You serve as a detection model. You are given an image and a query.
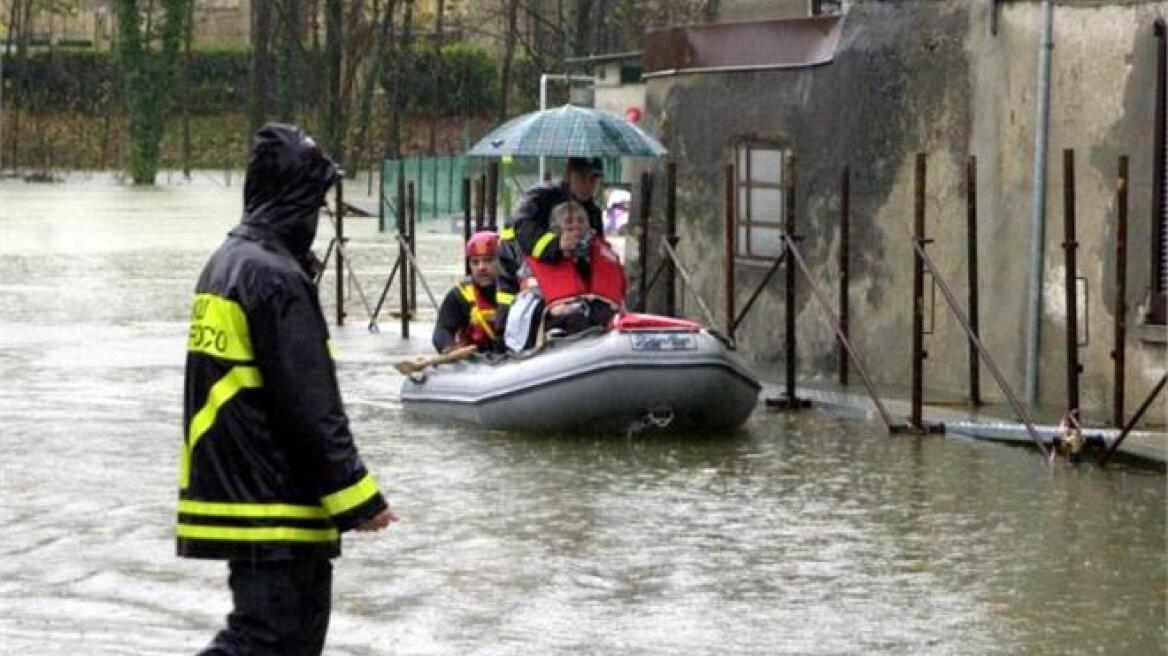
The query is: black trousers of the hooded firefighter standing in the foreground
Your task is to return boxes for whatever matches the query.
[200,559,333,656]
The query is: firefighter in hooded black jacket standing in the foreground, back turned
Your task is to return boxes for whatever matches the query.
[178,124,396,656]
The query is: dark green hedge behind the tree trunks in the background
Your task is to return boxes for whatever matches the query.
[4,43,499,116]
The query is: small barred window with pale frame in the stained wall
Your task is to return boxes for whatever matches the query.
[735,141,790,263]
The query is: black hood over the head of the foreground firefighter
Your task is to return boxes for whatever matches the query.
[243,123,340,258]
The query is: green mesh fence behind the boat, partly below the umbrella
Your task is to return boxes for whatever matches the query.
[381,155,621,232]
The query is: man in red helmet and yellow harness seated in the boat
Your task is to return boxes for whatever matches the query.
[433,231,499,353]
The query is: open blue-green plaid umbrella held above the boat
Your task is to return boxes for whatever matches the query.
[466,105,667,158]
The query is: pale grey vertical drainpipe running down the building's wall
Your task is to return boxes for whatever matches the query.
[1026,0,1055,407]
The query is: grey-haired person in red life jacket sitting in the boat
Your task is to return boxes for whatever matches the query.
[527,201,625,335]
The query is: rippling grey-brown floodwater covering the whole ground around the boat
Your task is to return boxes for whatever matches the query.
[0,176,1168,656]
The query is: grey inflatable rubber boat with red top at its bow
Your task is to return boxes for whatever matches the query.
[402,314,762,432]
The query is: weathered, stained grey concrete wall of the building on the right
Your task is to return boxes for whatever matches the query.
[627,0,1168,423]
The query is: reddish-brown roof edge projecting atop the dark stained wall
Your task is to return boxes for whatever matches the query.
[645,16,842,77]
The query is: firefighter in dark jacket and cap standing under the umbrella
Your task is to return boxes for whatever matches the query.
[495,158,604,333]
